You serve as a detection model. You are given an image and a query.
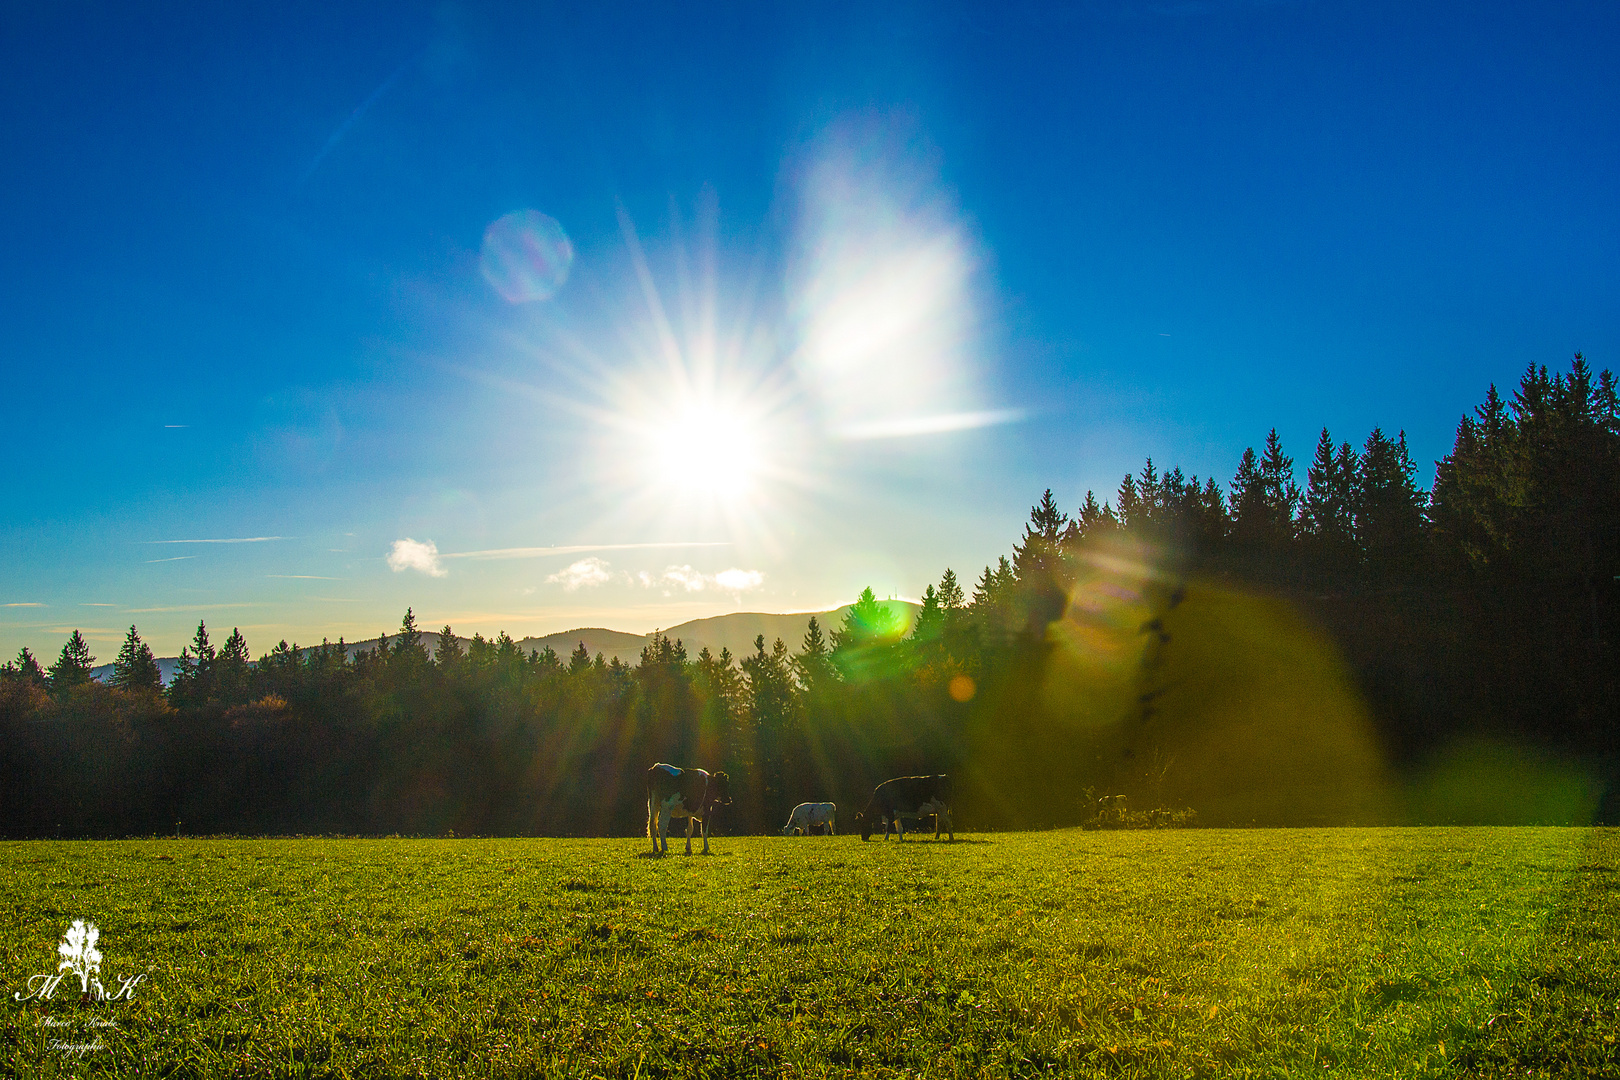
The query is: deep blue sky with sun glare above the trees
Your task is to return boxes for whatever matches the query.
[0,2,1620,659]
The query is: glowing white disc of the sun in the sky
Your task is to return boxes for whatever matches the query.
[646,403,765,502]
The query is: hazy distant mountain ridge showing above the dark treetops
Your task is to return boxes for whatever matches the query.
[91,601,917,685]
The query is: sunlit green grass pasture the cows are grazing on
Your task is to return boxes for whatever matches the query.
[0,829,1620,1077]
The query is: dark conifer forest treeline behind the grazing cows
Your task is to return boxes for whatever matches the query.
[0,355,1620,836]
